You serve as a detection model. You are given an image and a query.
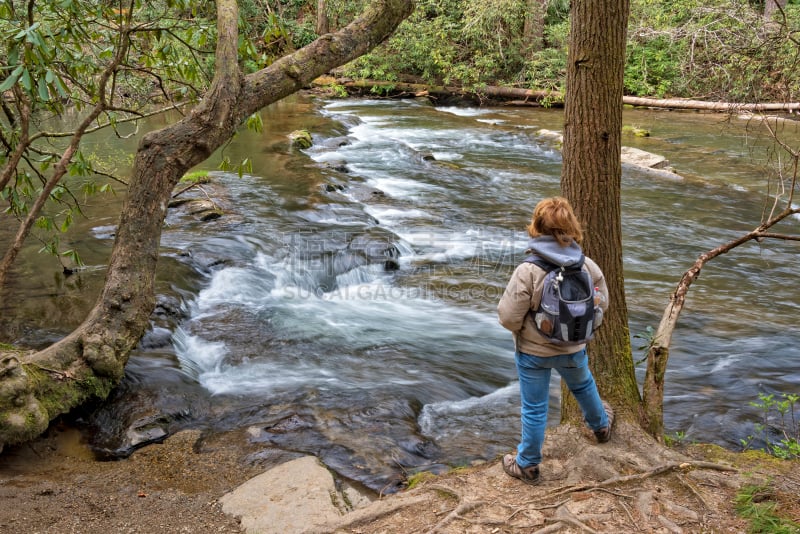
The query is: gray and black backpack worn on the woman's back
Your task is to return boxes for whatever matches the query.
[525,255,603,345]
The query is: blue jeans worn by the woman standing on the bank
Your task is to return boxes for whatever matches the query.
[515,349,608,468]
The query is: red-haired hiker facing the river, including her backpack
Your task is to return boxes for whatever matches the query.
[497,197,614,484]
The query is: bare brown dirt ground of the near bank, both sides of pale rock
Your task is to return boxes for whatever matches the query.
[0,425,800,534]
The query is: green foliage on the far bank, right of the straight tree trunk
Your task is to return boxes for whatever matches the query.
[625,0,800,102]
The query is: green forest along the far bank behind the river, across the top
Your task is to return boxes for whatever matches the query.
[252,0,800,102]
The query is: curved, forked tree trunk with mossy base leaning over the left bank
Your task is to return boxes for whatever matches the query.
[0,0,413,449]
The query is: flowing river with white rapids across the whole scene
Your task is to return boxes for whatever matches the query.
[3,96,800,489]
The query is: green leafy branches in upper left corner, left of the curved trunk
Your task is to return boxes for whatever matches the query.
[0,0,216,269]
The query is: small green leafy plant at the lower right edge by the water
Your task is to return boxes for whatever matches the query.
[741,393,800,460]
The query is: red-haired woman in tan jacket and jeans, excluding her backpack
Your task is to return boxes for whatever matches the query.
[497,197,614,484]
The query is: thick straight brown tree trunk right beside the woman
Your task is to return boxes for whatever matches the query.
[561,0,641,428]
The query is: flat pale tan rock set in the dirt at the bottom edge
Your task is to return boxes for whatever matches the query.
[220,456,371,534]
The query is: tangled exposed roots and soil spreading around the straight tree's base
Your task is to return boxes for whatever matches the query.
[326,428,746,534]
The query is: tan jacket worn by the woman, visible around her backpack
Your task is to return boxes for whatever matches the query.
[497,258,608,356]
